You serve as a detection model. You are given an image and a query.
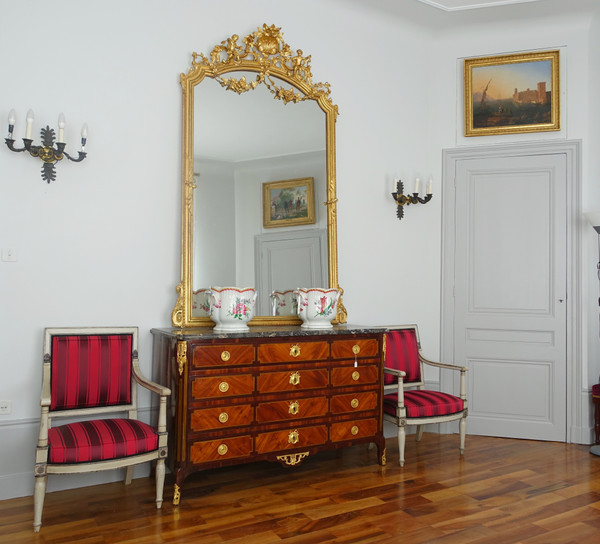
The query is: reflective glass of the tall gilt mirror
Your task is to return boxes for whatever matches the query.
[192,72,327,317]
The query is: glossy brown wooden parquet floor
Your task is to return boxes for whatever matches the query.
[0,433,600,544]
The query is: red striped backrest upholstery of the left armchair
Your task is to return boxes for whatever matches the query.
[50,334,132,410]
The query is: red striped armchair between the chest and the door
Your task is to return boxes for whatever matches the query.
[383,325,467,466]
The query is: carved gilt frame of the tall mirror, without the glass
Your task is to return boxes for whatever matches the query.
[171,24,347,328]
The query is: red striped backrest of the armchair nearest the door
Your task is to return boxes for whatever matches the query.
[384,325,421,384]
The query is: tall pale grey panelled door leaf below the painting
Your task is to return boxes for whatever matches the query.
[453,153,567,441]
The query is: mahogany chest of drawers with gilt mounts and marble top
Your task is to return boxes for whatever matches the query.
[152,326,385,504]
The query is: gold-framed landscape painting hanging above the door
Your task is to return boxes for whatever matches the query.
[465,50,560,136]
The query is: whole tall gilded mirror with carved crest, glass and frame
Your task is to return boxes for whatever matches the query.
[171,24,347,327]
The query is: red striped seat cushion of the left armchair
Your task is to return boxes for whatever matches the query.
[48,418,158,464]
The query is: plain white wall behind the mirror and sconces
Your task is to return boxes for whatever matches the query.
[0,0,599,498]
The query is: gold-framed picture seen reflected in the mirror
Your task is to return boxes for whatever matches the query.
[262,178,315,229]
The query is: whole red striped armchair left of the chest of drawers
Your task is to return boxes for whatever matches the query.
[33,327,171,532]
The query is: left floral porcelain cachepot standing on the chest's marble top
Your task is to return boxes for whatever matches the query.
[208,287,256,332]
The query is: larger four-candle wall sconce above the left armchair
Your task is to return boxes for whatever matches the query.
[4,110,87,183]
